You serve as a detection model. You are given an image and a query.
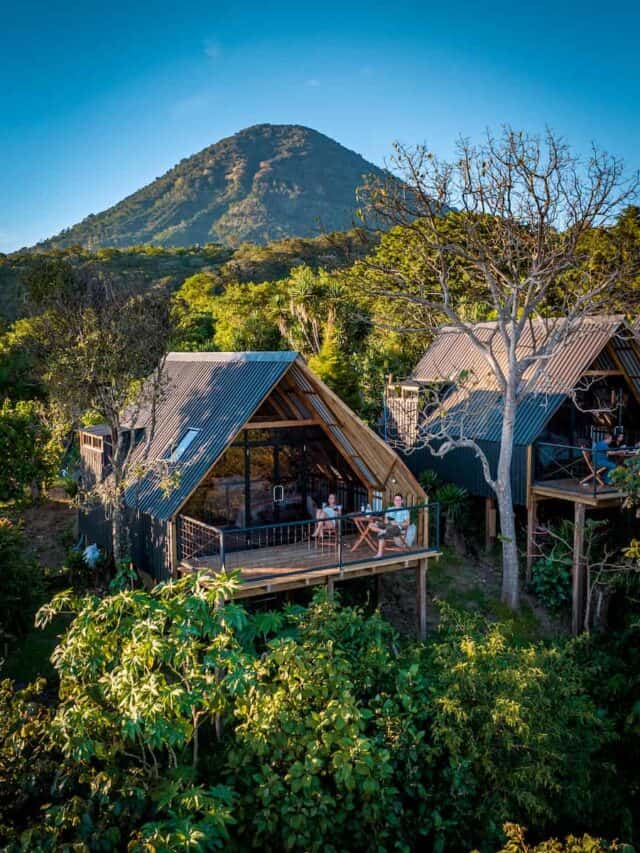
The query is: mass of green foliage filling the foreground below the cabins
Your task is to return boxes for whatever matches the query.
[0,578,610,853]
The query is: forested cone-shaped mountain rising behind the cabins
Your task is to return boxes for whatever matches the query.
[38,124,382,249]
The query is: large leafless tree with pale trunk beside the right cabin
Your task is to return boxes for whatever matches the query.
[362,128,638,608]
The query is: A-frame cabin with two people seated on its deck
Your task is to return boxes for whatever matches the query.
[80,352,437,628]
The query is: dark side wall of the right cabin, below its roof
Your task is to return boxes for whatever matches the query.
[403,441,527,506]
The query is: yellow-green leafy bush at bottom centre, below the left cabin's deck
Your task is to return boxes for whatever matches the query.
[229,605,401,850]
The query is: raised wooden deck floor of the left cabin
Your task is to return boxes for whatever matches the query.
[179,537,439,598]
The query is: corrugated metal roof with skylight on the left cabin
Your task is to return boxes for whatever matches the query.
[127,352,297,520]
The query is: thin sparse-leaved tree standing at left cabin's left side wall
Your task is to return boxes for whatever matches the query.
[27,260,171,563]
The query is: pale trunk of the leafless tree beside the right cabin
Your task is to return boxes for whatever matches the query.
[496,381,520,610]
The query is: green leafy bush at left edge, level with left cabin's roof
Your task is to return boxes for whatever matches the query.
[0,400,58,501]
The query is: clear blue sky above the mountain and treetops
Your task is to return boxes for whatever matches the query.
[0,0,640,252]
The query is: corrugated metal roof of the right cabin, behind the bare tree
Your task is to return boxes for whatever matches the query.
[411,315,628,444]
